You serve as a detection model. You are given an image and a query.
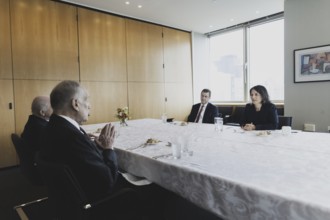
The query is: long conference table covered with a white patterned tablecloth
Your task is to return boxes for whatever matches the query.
[83,119,330,220]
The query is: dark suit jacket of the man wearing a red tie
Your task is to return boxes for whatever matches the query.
[188,103,219,124]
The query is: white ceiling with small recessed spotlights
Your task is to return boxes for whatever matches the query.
[62,0,284,34]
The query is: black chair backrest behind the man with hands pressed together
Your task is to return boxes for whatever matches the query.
[37,154,89,220]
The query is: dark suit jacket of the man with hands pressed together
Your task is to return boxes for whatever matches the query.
[40,114,118,199]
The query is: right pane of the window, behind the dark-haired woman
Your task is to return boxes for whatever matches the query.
[248,19,284,101]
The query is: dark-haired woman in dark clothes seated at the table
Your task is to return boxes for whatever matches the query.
[241,85,278,131]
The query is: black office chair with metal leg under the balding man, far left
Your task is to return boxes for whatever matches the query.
[11,133,47,219]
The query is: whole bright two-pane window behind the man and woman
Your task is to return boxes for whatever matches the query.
[209,16,284,103]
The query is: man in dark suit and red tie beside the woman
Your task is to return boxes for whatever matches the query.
[188,89,219,124]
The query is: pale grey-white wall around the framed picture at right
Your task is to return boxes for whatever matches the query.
[284,0,330,132]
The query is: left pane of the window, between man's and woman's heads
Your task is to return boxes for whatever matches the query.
[210,29,244,102]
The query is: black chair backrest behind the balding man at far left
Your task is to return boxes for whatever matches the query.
[11,133,43,185]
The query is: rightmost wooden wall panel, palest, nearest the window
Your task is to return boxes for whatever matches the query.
[163,28,193,121]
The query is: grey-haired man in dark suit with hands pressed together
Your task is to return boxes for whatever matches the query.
[40,80,141,219]
